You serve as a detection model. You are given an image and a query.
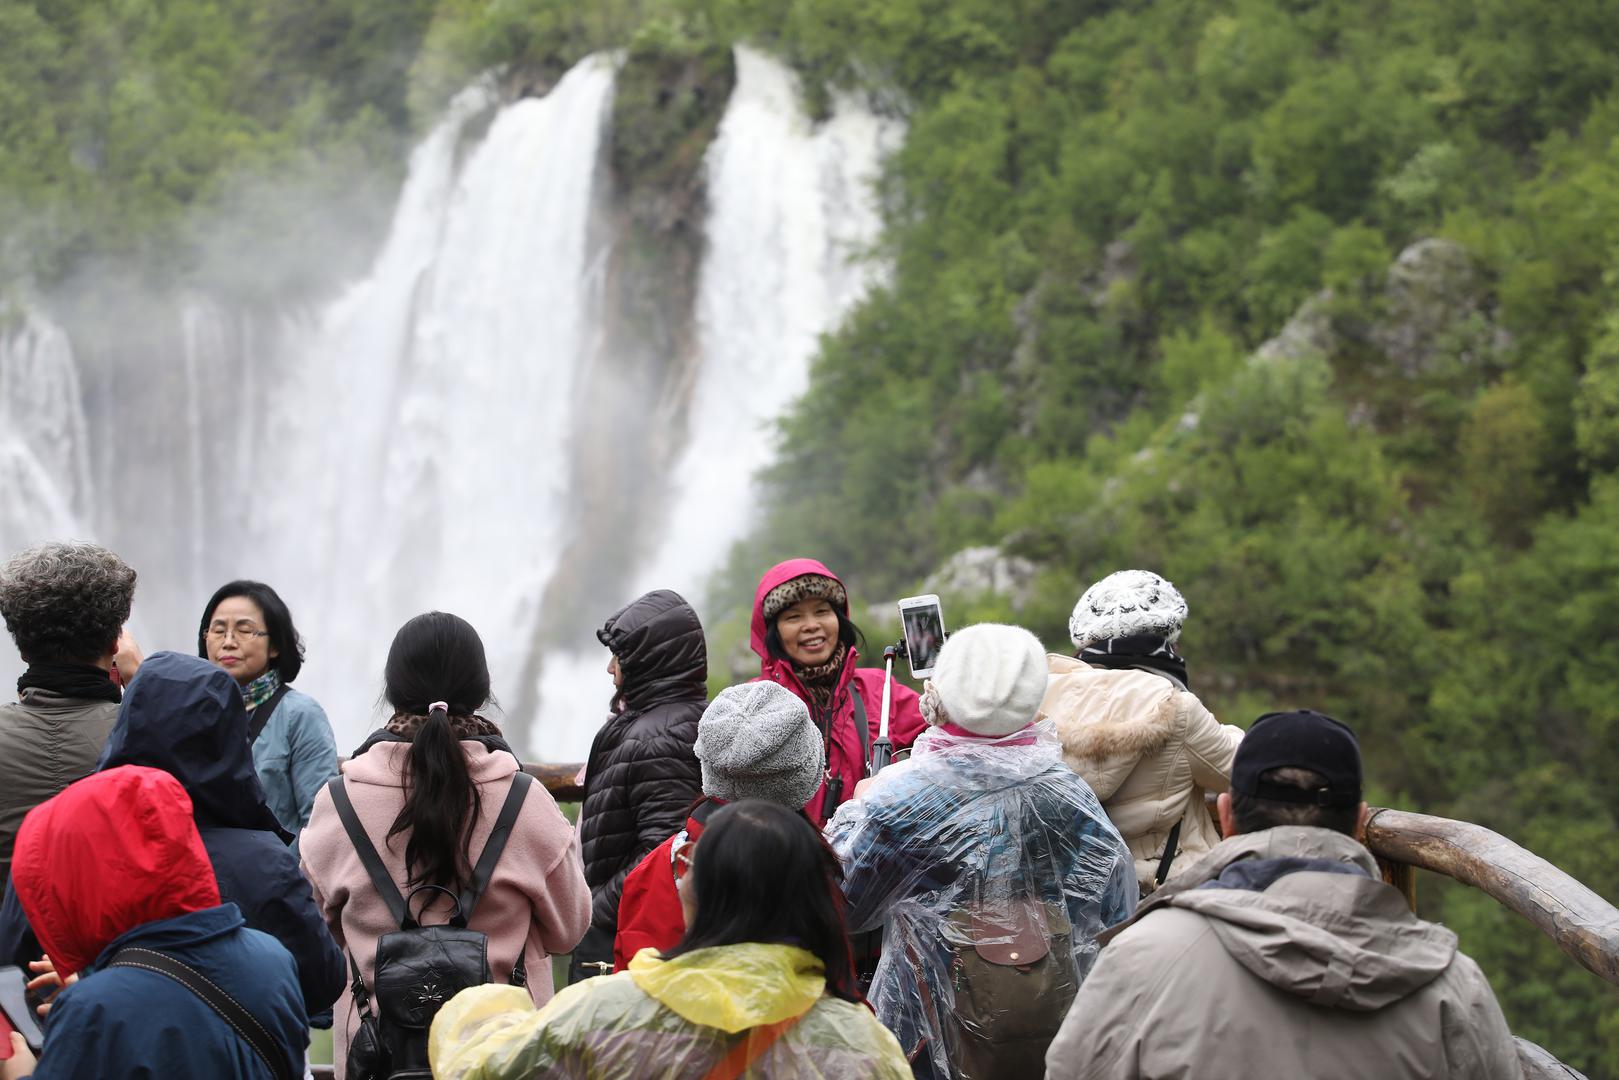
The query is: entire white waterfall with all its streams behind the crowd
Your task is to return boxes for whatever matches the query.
[0,50,897,761]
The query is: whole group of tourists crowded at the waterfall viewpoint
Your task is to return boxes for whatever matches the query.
[0,542,1522,1080]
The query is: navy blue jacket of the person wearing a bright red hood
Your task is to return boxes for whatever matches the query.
[34,904,309,1080]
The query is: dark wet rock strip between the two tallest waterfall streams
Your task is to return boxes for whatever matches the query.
[531,40,737,650]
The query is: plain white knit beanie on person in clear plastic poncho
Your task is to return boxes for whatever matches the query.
[928,622,1046,738]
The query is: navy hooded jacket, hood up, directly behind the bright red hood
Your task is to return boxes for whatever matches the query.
[0,653,346,1015]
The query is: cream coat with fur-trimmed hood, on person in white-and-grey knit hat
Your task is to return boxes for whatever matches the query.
[1039,654,1242,889]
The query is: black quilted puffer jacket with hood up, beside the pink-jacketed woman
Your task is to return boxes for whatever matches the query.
[580,589,708,939]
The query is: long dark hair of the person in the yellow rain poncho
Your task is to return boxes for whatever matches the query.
[664,798,861,1001]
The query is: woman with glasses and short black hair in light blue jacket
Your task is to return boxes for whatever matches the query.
[198,581,337,836]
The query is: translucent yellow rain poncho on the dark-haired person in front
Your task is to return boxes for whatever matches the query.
[427,944,911,1080]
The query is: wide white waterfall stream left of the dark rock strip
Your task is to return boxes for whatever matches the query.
[255,58,614,738]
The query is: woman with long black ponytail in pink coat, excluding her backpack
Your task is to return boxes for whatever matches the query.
[300,612,591,1080]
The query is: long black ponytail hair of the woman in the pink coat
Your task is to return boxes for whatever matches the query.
[382,612,489,886]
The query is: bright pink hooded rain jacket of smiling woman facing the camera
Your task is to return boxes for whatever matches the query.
[753,559,928,827]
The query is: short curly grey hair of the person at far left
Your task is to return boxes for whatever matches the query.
[0,541,134,664]
